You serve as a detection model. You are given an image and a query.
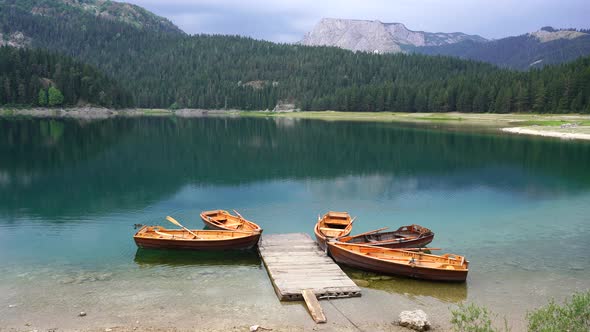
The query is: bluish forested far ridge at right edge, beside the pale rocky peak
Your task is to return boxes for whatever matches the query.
[413,27,590,70]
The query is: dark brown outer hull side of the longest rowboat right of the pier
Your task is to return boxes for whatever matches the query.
[327,243,468,282]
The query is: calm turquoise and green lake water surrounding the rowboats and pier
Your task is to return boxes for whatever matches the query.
[0,118,590,326]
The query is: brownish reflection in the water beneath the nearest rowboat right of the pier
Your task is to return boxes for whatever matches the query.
[342,266,468,303]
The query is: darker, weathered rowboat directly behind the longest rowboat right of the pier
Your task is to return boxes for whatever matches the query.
[338,224,434,248]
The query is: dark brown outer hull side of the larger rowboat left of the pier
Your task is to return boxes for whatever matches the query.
[134,233,261,250]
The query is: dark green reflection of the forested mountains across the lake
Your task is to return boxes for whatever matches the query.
[0,117,590,216]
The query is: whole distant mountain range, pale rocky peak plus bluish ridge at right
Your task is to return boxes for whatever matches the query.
[299,18,590,70]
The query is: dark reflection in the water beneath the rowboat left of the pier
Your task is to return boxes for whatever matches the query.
[134,248,261,267]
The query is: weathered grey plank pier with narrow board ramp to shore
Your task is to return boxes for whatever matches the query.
[258,233,361,322]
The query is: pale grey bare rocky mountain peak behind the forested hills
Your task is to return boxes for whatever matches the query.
[300,18,487,53]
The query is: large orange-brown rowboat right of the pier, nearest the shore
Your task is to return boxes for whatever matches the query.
[328,241,469,282]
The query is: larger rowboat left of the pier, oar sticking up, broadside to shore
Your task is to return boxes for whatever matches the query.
[133,226,261,250]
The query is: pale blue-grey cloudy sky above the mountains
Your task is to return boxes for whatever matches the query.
[130,0,590,42]
